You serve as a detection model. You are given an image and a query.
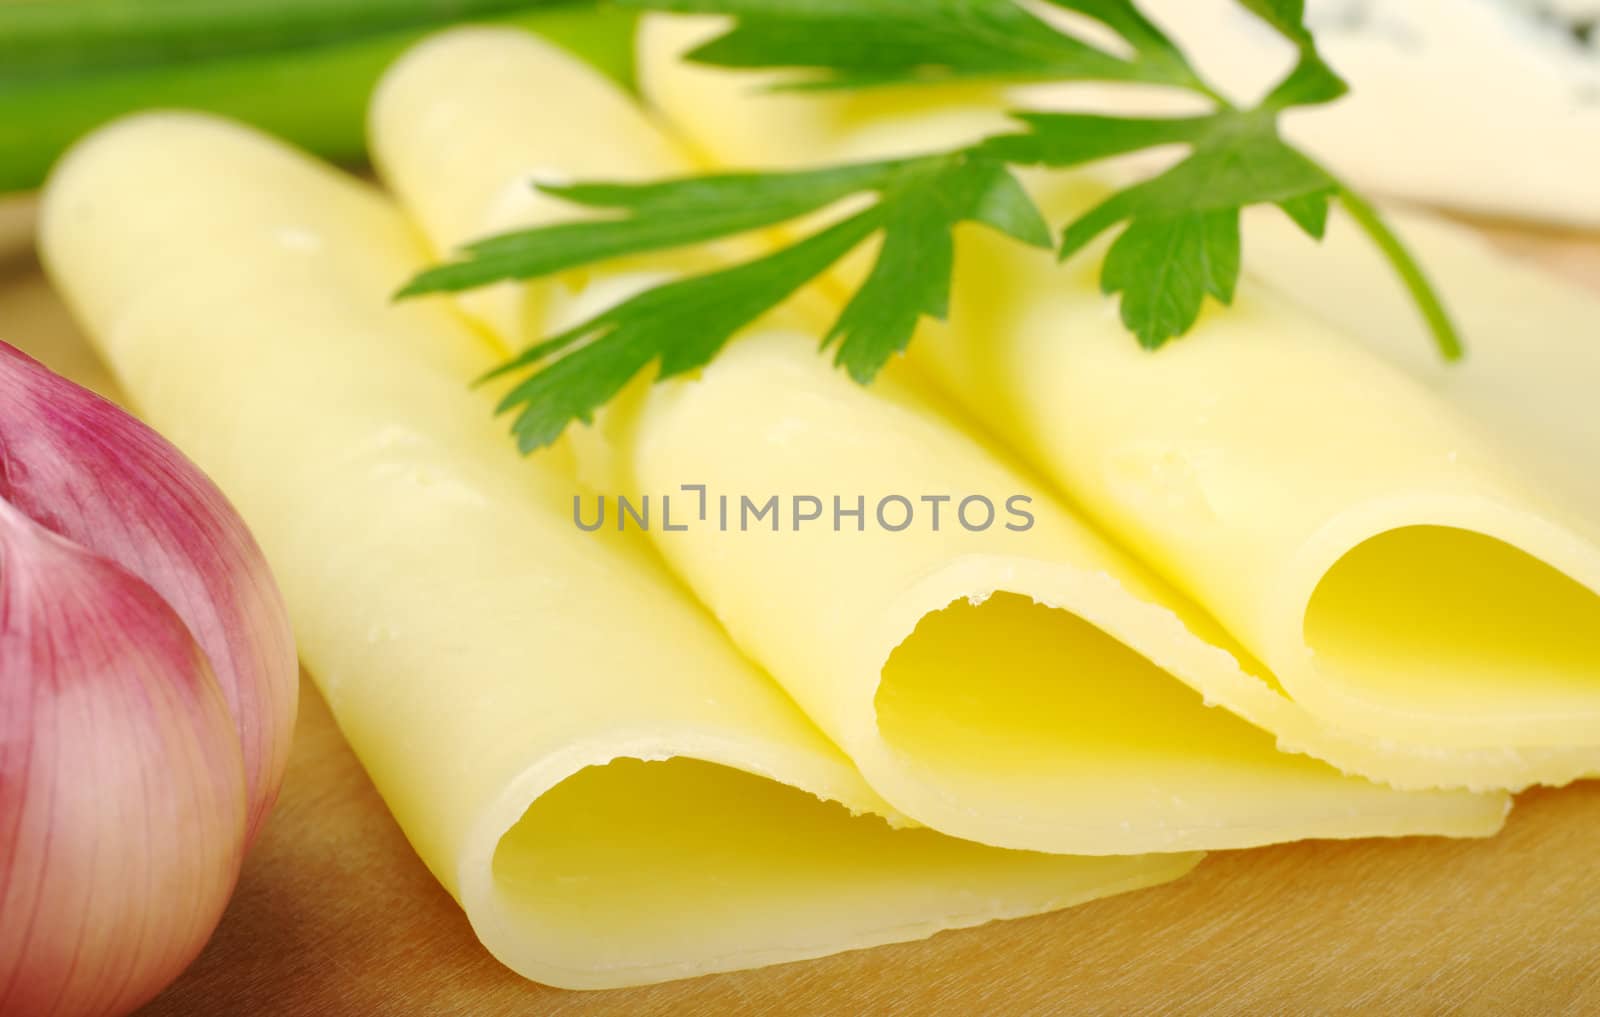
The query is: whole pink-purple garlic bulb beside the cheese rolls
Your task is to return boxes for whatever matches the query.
[0,342,298,1017]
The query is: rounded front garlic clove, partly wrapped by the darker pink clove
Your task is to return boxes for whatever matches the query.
[0,498,248,1017]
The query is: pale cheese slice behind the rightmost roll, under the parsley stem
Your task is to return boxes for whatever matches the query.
[1246,209,1600,521]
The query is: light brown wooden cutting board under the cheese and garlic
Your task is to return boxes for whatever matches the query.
[0,198,1600,1017]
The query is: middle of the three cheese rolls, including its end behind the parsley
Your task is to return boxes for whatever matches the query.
[373,30,1506,854]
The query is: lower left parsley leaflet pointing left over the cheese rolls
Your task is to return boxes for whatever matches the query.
[444,150,1051,451]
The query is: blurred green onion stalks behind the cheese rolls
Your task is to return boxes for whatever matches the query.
[0,0,634,193]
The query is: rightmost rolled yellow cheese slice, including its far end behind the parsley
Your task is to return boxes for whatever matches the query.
[630,22,1600,788]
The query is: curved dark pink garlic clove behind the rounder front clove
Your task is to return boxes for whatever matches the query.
[0,342,299,843]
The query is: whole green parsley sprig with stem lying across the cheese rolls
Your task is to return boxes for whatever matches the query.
[402,0,1461,451]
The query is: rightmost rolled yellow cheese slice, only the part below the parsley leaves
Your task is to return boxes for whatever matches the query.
[918,200,1600,787]
